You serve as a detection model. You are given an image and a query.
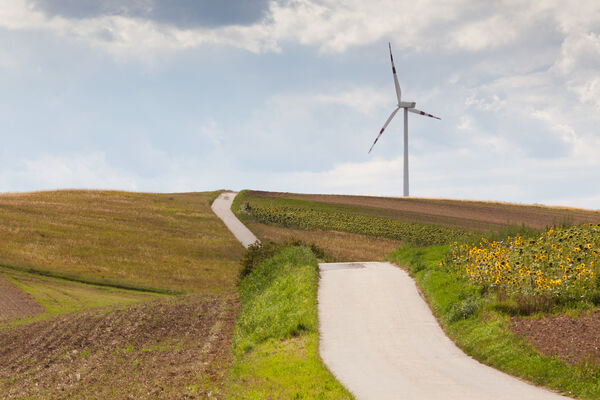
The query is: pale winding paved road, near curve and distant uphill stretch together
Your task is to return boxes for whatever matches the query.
[213,193,566,400]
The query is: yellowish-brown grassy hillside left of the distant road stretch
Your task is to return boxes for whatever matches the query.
[0,191,243,293]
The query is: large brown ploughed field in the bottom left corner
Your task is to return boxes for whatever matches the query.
[0,295,238,399]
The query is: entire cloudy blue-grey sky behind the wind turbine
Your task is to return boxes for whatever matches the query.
[0,0,600,209]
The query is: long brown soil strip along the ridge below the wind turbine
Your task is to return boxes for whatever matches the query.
[248,191,600,230]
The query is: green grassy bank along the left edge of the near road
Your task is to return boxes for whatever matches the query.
[229,246,352,399]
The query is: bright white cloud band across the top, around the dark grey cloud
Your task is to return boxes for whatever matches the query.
[0,0,600,59]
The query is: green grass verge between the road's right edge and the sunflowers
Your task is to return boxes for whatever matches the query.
[388,246,600,399]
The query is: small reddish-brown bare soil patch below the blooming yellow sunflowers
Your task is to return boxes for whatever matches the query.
[511,310,600,364]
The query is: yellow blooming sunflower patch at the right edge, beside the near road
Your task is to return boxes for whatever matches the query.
[442,224,600,299]
